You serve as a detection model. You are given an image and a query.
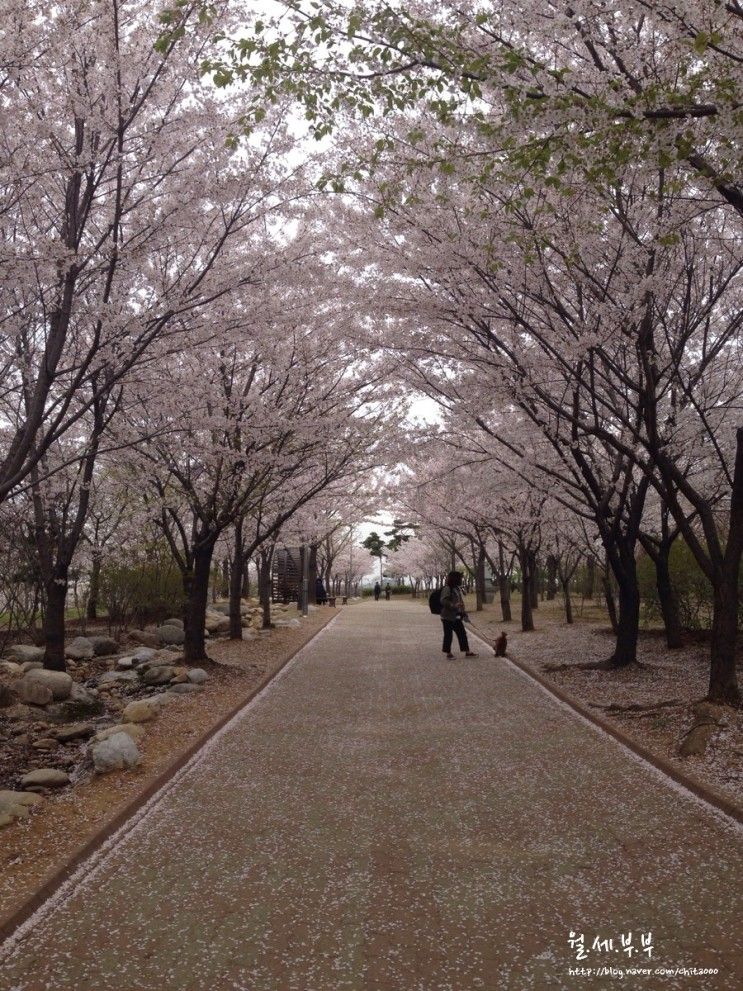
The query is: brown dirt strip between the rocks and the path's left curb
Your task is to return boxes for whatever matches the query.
[0,607,334,918]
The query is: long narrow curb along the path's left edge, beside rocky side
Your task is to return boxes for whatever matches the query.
[0,609,340,946]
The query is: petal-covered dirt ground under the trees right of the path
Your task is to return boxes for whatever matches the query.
[469,599,743,807]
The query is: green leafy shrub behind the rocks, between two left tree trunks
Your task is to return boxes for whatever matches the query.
[100,548,183,626]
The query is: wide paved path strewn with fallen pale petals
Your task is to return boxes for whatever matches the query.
[0,602,743,991]
